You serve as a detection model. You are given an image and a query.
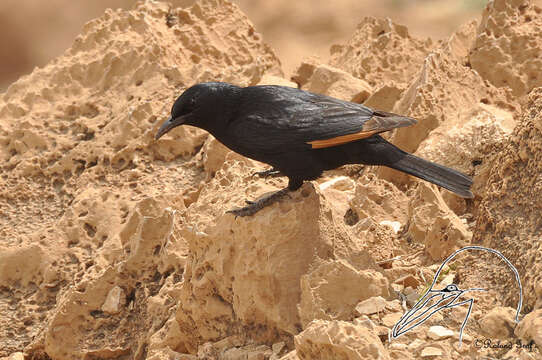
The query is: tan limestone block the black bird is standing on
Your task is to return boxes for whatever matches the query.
[177,174,372,351]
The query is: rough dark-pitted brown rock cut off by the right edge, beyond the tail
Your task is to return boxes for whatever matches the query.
[473,89,542,306]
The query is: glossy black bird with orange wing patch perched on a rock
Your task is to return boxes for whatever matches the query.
[155,82,473,217]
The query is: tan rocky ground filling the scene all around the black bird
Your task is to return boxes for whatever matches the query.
[0,0,542,360]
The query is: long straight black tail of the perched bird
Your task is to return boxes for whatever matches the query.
[386,153,474,198]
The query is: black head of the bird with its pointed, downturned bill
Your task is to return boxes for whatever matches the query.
[154,82,239,140]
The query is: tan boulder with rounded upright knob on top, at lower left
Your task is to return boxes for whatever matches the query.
[43,198,187,359]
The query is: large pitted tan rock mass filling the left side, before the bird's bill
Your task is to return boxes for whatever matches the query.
[0,0,281,359]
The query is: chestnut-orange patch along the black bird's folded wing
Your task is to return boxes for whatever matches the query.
[307,111,417,149]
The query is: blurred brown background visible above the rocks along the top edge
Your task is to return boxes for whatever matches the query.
[0,0,485,89]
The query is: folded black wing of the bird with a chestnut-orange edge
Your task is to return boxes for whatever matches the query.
[227,86,416,152]
